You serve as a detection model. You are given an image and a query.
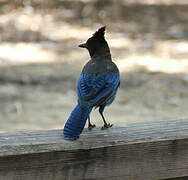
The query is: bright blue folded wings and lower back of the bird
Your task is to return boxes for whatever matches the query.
[77,73,120,106]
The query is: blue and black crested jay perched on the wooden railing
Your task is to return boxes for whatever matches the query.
[63,26,120,141]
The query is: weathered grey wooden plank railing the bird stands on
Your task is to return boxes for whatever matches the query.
[0,120,188,180]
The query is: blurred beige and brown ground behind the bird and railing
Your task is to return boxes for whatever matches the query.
[0,0,188,131]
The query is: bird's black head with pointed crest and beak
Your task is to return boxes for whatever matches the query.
[79,26,110,57]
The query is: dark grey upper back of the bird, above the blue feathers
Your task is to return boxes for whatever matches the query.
[82,60,119,74]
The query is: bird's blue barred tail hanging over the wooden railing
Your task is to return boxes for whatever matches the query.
[63,104,92,140]
